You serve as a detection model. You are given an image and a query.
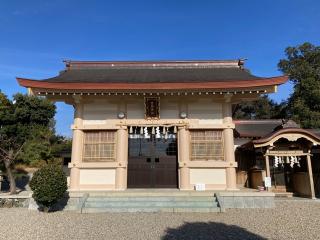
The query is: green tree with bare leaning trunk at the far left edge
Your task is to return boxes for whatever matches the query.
[0,92,55,194]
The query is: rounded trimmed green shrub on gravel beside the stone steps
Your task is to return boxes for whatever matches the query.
[30,164,68,212]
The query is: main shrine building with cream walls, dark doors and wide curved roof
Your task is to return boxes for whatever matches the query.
[17,60,288,191]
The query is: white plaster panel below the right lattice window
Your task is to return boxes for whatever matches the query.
[190,168,226,184]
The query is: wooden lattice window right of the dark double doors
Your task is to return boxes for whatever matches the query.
[190,130,224,161]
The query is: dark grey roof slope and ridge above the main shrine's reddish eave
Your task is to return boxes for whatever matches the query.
[37,61,260,83]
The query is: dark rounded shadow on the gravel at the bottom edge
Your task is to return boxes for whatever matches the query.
[161,222,266,240]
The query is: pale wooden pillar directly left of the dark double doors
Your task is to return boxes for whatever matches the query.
[115,128,128,190]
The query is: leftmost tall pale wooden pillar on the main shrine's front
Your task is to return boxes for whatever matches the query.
[69,98,83,190]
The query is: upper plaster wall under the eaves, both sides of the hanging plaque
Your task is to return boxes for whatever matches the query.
[83,96,222,125]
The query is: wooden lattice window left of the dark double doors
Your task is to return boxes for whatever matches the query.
[83,131,116,162]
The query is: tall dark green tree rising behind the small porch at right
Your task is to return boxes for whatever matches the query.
[278,43,320,128]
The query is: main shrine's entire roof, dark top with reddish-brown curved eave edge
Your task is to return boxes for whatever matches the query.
[17,60,288,90]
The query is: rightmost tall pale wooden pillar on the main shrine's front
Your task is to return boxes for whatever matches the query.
[223,98,238,190]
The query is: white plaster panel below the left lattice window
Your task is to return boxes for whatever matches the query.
[80,169,116,185]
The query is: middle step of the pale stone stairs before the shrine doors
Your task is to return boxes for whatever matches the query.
[84,201,217,208]
